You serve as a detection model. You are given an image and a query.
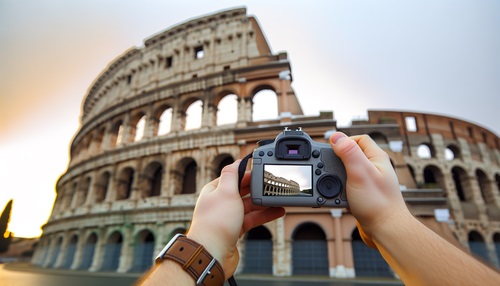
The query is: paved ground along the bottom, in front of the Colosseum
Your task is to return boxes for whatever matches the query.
[0,263,403,286]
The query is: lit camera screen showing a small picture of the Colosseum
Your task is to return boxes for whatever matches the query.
[263,165,313,197]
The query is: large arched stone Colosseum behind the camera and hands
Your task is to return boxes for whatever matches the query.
[32,8,500,278]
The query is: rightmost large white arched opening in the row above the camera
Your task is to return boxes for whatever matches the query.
[252,89,278,122]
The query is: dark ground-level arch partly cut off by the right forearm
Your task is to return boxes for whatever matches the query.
[351,228,393,277]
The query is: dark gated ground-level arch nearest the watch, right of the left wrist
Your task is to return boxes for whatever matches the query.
[243,225,273,274]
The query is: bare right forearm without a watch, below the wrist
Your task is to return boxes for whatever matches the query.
[373,212,500,285]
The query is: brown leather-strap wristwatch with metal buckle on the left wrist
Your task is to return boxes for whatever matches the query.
[155,234,225,286]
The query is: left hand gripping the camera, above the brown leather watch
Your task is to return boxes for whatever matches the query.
[187,160,285,280]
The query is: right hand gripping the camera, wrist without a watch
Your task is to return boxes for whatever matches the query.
[330,132,411,248]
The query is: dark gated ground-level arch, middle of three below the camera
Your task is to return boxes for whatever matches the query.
[292,223,329,275]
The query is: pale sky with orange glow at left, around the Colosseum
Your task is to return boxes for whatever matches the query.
[0,0,500,237]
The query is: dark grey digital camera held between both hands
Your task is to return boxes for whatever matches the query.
[250,128,349,208]
